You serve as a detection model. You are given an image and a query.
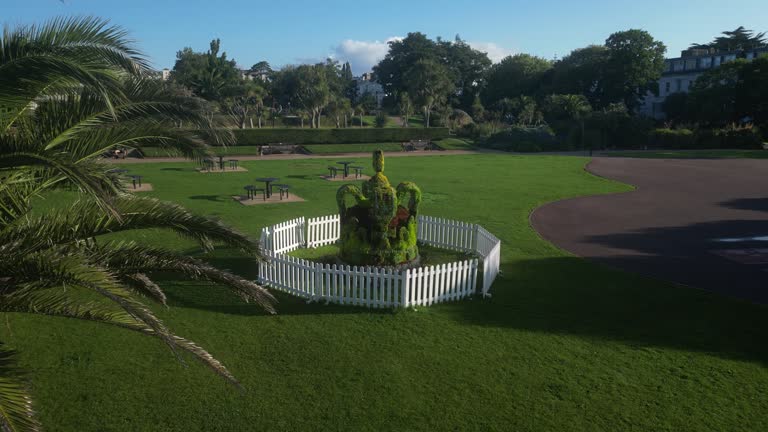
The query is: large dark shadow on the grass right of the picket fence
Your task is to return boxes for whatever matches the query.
[439,257,768,364]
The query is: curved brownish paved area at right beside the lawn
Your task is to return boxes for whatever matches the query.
[531,158,768,303]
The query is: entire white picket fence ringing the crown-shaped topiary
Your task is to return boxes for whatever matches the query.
[259,215,501,308]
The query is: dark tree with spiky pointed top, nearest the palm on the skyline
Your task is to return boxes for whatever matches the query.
[171,39,242,101]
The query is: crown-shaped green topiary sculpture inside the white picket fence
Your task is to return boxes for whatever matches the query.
[336,150,421,266]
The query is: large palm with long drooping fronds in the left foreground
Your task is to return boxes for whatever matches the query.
[0,18,274,431]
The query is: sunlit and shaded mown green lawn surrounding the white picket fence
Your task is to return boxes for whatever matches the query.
[7,154,768,431]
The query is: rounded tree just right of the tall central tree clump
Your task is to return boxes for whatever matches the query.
[483,54,552,106]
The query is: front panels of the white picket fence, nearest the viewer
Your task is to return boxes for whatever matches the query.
[258,253,477,308]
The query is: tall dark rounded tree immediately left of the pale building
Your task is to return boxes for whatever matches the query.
[604,30,667,110]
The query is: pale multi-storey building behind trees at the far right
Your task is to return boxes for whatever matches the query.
[639,47,768,120]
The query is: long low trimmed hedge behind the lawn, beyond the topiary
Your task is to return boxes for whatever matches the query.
[228,128,448,145]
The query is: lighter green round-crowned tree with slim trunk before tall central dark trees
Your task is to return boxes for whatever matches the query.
[405,60,454,127]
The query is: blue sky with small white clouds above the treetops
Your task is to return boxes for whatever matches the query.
[6,0,768,73]
